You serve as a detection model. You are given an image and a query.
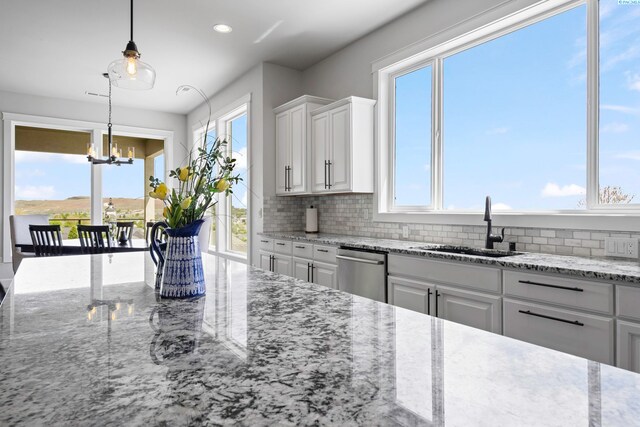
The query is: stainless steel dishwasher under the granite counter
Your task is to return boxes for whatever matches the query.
[336,246,387,302]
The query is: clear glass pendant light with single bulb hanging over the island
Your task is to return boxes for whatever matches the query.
[107,0,156,90]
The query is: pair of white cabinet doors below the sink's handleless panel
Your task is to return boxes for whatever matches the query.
[387,276,502,334]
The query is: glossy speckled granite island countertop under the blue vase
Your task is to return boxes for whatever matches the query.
[0,253,640,427]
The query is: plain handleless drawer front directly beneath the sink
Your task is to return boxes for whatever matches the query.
[388,255,502,293]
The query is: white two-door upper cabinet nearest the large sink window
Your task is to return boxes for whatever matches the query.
[311,96,376,193]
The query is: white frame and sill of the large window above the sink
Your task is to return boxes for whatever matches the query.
[372,0,640,230]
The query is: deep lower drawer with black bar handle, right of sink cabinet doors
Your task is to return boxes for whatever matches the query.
[503,298,614,365]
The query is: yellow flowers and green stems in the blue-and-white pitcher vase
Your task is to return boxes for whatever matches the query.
[149,86,242,228]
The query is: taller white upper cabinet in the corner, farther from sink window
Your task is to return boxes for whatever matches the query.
[273,95,333,195]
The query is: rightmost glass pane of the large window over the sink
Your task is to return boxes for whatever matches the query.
[598,0,640,205]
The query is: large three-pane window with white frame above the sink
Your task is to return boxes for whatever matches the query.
[378,0,640,219]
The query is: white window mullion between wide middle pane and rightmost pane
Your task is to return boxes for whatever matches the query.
[587,0,600,209]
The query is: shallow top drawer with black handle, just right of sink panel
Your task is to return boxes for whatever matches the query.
[504,271,613,314]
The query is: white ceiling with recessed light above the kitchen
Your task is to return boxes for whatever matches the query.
[0,0,426,114]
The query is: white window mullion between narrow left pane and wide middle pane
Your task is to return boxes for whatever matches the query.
[431,57,443,210]
